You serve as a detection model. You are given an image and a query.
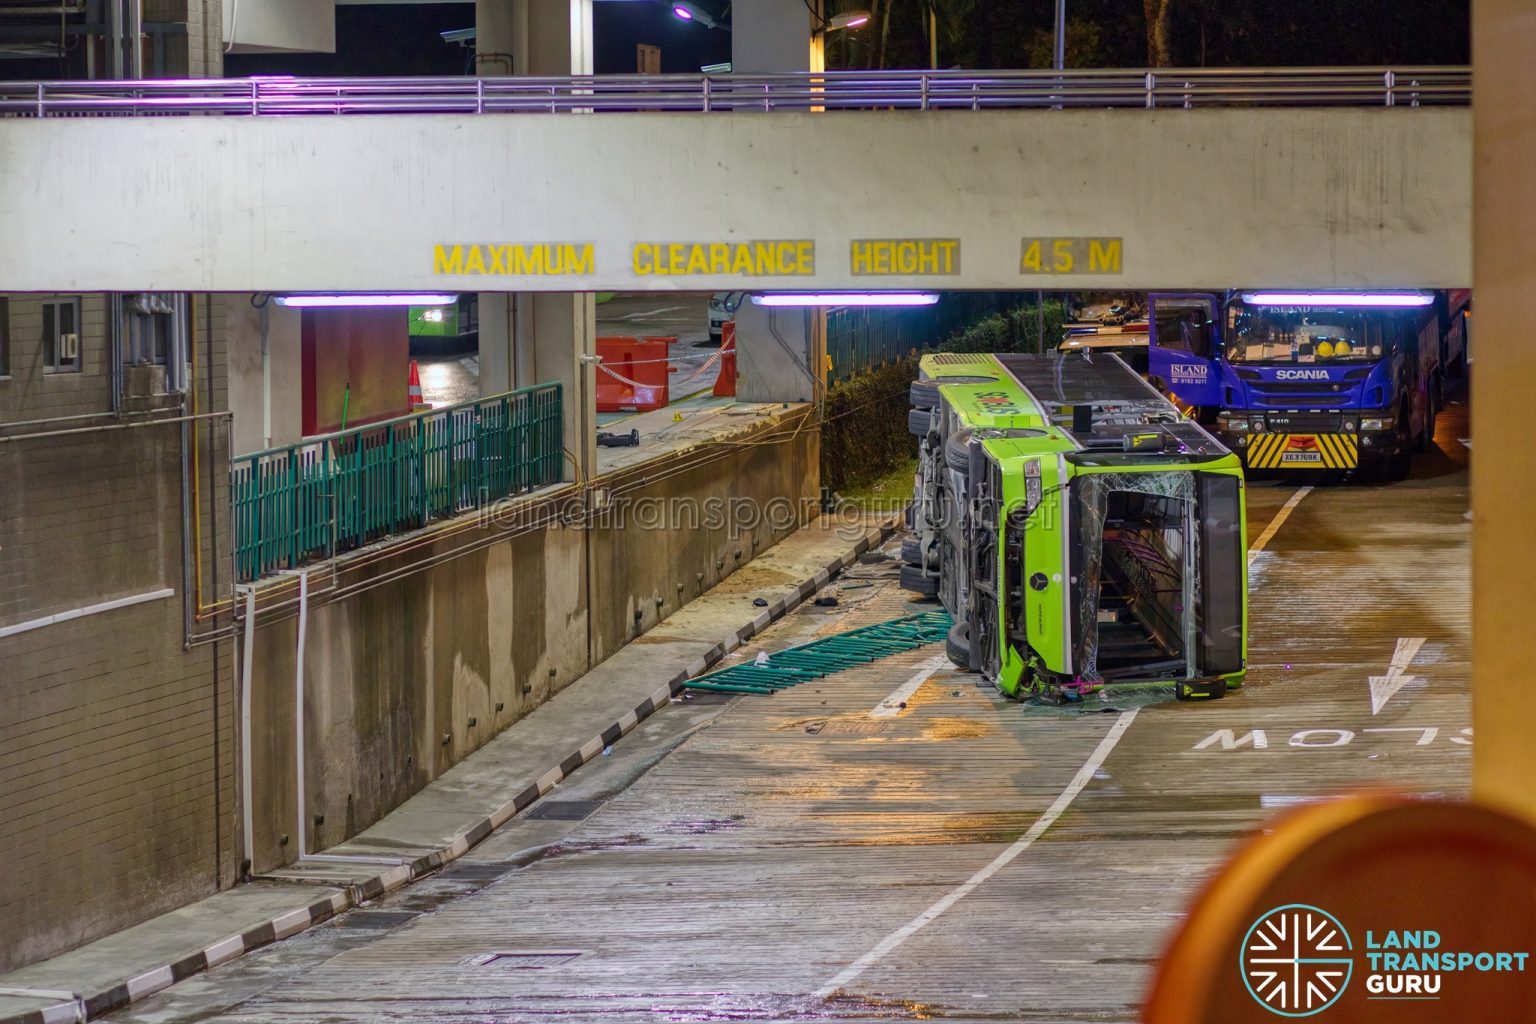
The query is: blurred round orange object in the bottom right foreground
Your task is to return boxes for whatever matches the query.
[1143,795,1536,1024]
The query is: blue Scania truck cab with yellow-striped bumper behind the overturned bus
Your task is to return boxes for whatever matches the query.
[1147,292,1442,479]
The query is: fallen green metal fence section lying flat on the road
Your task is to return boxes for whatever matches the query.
[688,609,951,694]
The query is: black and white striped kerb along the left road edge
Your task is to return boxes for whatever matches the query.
[0,517,900,1024]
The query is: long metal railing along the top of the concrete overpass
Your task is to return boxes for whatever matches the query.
[0,66,1471,117]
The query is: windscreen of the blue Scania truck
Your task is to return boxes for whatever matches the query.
[1227,306,1384,365]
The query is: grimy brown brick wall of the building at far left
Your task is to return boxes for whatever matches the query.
[0,295,240,973]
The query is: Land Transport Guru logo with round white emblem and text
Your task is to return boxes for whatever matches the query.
[1238,903,1530,1016]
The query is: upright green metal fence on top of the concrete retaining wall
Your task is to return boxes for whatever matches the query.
[229,384,564,582]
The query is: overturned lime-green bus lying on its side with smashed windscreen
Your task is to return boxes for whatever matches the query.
[902,353,1247,702]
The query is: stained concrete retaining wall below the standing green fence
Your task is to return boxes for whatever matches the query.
[241,410,819,872]
